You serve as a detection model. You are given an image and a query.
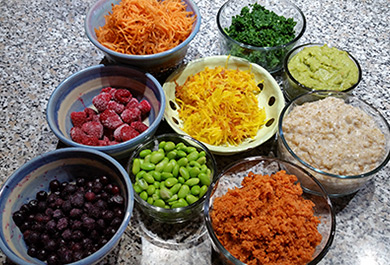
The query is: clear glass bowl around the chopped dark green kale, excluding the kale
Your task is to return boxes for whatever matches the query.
[217,0,306,73]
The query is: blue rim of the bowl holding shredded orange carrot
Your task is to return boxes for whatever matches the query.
[84,0,201,61]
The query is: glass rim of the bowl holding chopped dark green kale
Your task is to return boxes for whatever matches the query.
[217,0,306,52]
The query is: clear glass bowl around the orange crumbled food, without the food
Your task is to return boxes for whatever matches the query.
[204,156,336,265]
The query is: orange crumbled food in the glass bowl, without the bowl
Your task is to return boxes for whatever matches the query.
[210,170,322,265]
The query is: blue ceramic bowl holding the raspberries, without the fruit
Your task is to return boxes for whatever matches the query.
[46,65,165,158]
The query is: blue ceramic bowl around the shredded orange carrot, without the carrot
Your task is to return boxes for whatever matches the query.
[85,0,201,74]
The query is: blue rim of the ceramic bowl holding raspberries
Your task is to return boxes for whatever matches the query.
[46,64,166,152]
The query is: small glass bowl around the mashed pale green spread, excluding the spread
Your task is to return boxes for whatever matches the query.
[283,43,362,100]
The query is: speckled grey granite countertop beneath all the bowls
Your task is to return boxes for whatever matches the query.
[0,0,390,265]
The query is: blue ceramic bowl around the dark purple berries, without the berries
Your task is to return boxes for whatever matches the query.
[0,148,134,265]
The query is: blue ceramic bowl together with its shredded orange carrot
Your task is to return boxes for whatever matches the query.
[85,0,201,74]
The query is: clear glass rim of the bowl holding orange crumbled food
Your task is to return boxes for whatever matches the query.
[203,156,336,265]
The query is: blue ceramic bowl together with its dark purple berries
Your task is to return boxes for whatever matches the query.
[0,148,134,265]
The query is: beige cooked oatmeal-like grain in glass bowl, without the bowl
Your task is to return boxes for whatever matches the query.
[282,97,385,176]
